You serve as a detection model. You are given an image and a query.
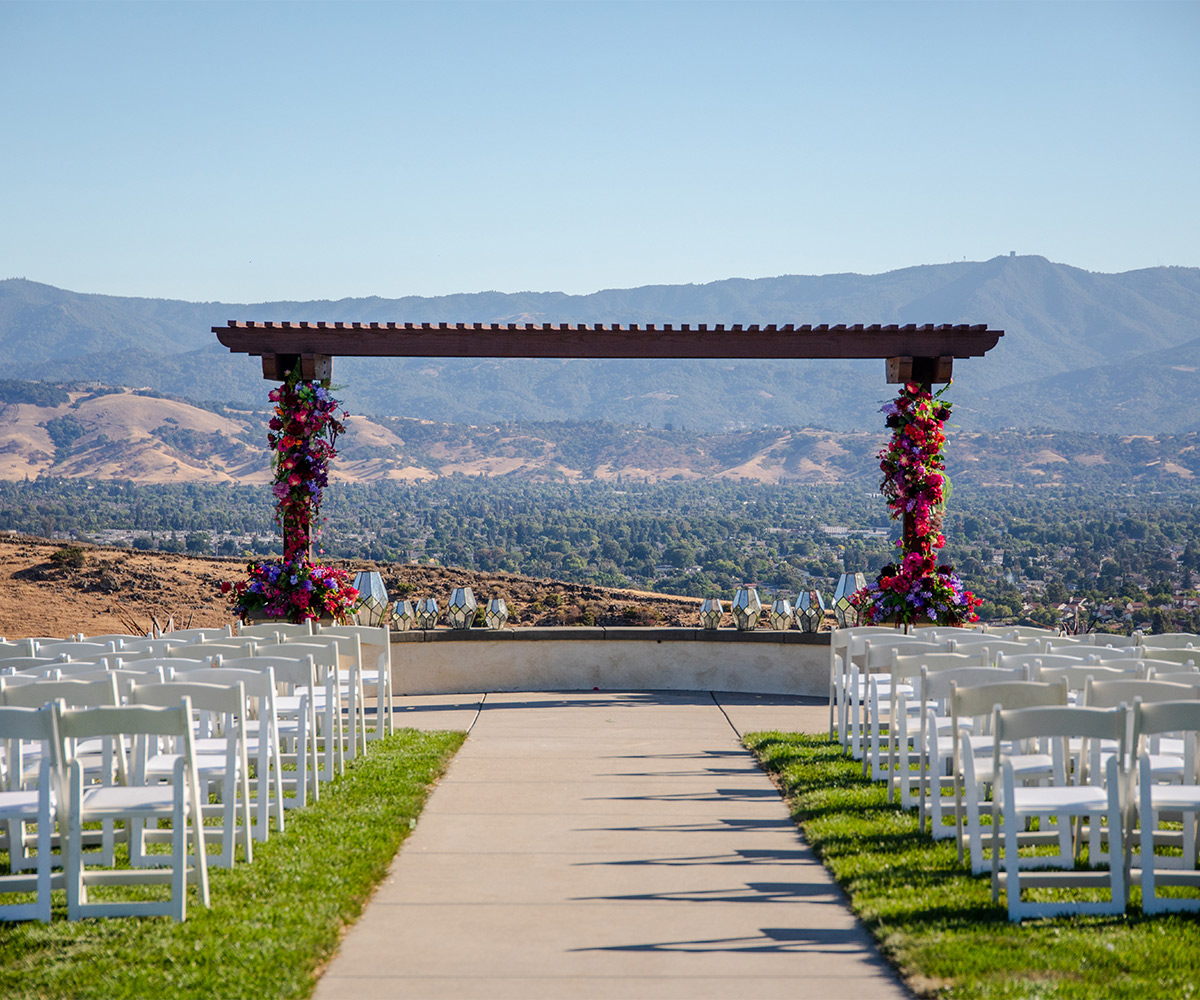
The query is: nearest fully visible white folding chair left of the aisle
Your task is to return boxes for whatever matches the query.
[56,699,209,921]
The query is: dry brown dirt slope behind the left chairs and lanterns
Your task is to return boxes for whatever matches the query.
[0,535,700,639]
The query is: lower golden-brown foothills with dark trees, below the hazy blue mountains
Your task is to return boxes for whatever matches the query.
[0,379,1200,490]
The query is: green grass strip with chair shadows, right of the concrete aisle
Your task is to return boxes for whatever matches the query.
[744,732,1200,1000]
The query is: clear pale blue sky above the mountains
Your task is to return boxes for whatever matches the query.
[0,0,1200,303]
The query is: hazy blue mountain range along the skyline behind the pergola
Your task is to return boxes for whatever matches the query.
[0,257,1200,433]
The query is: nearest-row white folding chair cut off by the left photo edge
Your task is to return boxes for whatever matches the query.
[0,706,62,923]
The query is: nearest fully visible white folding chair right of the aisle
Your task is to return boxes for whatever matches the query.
[991,706,1129,922]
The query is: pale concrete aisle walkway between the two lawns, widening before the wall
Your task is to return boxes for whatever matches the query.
[316,691,908,1000]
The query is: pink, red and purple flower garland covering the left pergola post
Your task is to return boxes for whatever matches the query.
[221,365,359,622]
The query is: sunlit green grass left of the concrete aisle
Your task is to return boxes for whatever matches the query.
[0,730,466,1000]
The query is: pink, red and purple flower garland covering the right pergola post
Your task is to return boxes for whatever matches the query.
[852,382,982,625]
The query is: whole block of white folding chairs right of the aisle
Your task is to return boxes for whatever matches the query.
[830,629,1200,920]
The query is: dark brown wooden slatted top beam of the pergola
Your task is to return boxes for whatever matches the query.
[212,319,1004,384]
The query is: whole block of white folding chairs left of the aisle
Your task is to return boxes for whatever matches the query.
[0,624,403,920]
